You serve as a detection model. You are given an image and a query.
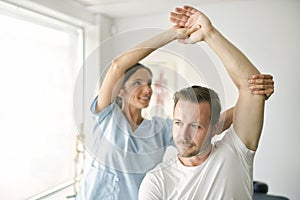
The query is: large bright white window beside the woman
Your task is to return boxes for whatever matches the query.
[0,2,83,199]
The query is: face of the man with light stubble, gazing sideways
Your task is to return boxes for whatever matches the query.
[173,100,211,157]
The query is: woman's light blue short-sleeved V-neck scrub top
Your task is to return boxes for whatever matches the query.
[76,97,173,200]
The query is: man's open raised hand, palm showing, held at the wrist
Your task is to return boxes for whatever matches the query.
[170,6,214,44]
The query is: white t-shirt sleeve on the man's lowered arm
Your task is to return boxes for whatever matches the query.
[139,171,163,200]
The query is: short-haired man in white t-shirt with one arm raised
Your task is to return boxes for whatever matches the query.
[139,6,265,200]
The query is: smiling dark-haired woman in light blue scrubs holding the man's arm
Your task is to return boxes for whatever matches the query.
[76,27,273,200]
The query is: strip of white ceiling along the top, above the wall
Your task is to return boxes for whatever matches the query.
[70,0,234,18]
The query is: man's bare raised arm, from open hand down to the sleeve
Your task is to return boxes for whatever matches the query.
[170,6,265,150]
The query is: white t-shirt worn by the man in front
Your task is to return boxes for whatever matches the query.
[139,127,255,200]
